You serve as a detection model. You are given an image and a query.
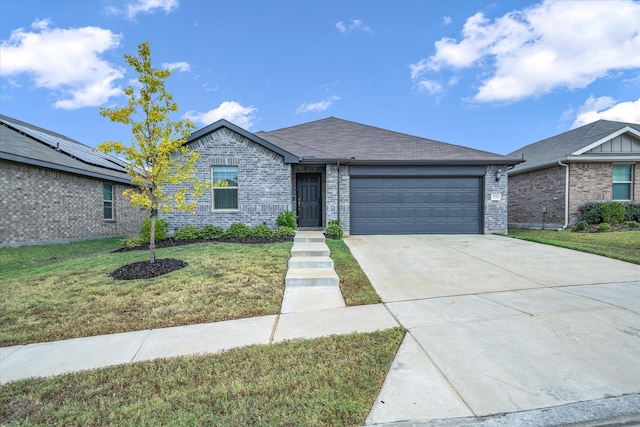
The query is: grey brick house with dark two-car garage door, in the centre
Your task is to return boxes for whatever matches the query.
[166,117,521,235]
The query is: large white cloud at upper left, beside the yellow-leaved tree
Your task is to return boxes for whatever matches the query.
[0,20,124,109]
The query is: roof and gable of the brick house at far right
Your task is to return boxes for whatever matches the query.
[507,120,640,173]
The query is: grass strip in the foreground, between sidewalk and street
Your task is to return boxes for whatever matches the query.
[0,329,404,426]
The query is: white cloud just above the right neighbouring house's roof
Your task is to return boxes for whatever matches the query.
[571,96,640,129]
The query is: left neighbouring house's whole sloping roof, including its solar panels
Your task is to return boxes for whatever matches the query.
[0,115,131,184]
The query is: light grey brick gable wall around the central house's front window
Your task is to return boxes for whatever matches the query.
[162,128,292,232]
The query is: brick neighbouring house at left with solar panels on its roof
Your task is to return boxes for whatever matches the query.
[0,115,144,246]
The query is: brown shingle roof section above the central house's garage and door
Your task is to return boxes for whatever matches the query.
[255,117,520,165]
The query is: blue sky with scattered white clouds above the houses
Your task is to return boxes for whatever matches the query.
[0,0,640,154]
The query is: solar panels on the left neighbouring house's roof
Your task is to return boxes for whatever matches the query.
[4,120,125,172]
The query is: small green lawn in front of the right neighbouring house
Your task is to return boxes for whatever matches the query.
[509,229,640,264]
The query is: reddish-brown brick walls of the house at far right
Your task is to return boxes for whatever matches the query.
[509,162,640,228]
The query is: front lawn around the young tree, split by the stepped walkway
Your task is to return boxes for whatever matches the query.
[0,239,379,346]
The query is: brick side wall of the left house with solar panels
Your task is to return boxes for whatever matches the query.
[0,160,145,246]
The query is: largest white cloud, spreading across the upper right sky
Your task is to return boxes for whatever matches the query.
[410,0,640,102]
